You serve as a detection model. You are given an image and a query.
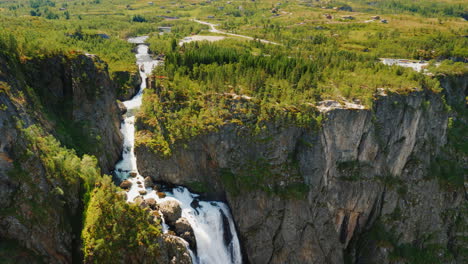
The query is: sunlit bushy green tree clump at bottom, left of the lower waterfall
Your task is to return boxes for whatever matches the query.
[82,176,161,263]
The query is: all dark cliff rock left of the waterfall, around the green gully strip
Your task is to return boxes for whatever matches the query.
[0,53,122,263]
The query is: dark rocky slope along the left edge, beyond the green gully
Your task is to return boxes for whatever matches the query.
[0,56,81,263]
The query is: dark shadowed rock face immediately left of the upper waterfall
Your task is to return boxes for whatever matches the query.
[25,55,123,174]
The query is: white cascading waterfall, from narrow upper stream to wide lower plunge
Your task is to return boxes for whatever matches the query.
[115,36,242,264]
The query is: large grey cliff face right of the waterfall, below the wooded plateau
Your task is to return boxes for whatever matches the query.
[136,88,466,263]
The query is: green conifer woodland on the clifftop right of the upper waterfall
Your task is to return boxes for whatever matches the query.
[137,39,438,156]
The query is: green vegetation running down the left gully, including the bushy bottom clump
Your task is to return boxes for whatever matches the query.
[11,126,165,263]
